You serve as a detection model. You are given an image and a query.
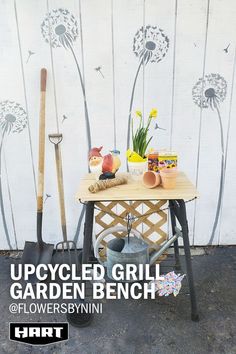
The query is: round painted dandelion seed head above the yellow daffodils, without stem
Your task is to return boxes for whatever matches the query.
[133,25,169,64]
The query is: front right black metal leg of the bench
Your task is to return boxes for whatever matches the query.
[178,200,199,321]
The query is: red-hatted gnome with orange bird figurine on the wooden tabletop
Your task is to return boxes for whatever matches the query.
[89,146,121,179]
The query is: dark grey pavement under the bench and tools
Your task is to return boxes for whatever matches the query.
[0,247,236,354]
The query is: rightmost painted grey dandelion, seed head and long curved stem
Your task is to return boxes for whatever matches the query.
[192,74,227,244]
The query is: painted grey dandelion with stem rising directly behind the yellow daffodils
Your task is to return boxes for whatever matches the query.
[127,25,169,154]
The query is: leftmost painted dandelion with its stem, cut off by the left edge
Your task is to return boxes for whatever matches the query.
[0,100,28,249]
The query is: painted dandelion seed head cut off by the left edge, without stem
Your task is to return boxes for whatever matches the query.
[0,101,28,133]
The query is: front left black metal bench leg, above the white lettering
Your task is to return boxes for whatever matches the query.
[82,202,94,264]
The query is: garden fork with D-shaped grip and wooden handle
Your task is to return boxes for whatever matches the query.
[48,134,78,269]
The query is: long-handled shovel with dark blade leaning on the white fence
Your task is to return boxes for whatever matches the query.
[21,69,54,283]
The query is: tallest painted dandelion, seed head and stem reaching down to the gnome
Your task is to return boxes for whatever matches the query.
[41,9,91,151]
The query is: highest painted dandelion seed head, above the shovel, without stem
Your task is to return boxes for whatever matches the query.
[41,9,79,49]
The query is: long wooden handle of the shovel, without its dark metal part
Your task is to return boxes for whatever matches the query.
[37,69,47,213]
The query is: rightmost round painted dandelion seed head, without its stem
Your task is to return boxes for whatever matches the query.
[192,74,227,109]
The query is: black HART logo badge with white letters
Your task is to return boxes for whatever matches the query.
[9,322,69,345]
